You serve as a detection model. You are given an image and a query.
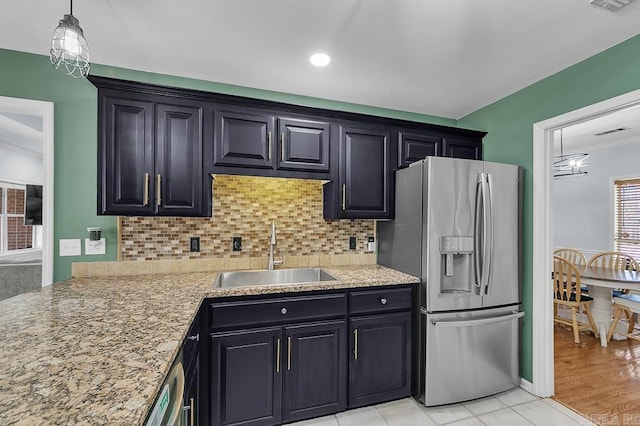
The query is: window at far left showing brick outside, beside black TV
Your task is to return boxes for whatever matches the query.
[0,182,33,253]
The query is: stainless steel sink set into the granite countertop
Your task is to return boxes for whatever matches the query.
[214,268,337,287]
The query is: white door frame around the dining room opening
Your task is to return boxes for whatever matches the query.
[532,90,640,397]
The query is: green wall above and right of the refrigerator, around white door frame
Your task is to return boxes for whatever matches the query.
[458,32,640,380]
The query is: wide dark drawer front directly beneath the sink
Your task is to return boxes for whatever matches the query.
[211,294,347,328]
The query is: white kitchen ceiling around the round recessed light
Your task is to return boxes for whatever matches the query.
[0,0,640,118]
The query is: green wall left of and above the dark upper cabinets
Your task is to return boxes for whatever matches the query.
[0,49,456,281]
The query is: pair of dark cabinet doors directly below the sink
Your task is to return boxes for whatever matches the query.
[211,320,347,425]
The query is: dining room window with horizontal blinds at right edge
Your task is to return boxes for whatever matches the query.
[614,178,640,261]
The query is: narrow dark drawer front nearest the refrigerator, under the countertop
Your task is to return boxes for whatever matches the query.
[349,287,412,314]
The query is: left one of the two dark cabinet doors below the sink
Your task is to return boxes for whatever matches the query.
[210,327,283,425]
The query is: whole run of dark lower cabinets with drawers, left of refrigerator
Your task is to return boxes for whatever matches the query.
[206,286,413,426]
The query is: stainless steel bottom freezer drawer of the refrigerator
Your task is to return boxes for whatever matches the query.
[419,305,524,406]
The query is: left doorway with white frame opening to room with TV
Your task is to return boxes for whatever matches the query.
[0,96,54,298]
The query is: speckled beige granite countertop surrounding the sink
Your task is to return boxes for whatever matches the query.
[0,265,419,425]
